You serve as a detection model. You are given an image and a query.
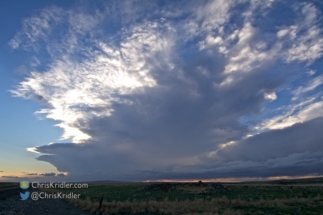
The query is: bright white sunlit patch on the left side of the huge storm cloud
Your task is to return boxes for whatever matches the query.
[12,18,172,142]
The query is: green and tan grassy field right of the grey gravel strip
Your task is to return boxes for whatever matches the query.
[43,183,323,215]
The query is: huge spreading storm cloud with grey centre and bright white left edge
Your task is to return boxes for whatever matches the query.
[9,1,323,179]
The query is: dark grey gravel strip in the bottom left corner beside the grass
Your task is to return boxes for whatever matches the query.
[0,184,91,215]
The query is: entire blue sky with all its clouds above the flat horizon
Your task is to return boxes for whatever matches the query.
[0,0,323,181]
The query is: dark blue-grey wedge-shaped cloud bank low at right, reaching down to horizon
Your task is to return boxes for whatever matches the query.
[190,117,323,177]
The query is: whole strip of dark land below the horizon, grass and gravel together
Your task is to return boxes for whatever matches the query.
[0,178,323,215]
